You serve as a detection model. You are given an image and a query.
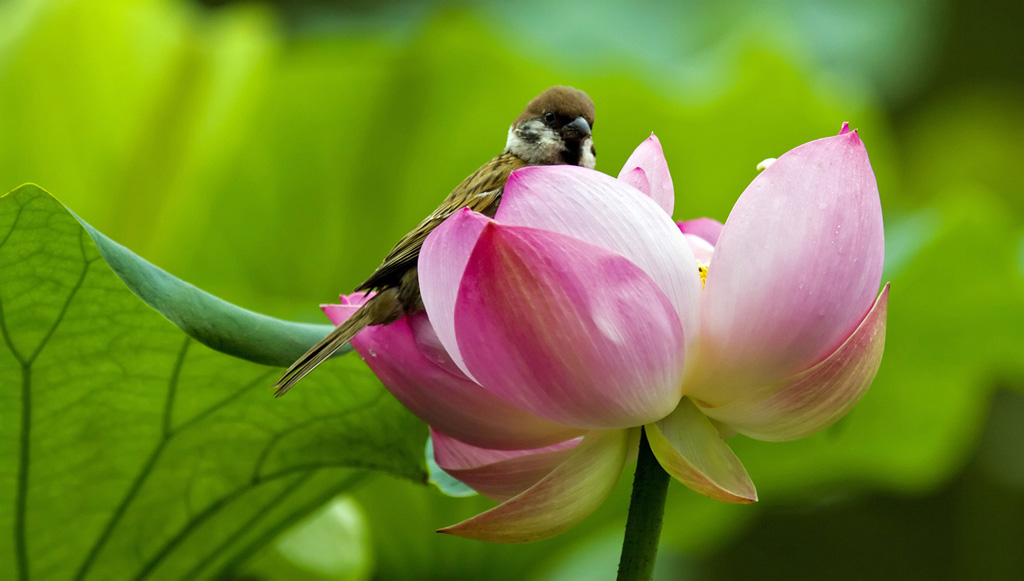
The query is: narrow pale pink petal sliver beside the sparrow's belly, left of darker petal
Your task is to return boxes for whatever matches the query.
[418,208,490,378]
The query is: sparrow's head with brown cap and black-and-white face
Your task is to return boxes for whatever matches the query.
[505,86,597,169]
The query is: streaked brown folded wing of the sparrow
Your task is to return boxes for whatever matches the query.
[355,153,526,291]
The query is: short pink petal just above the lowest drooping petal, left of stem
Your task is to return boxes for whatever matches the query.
[430,428,580,502]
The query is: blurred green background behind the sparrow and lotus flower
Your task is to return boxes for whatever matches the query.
[0,0,1024,579]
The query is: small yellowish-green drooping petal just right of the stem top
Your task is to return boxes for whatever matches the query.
[644,398,758,504]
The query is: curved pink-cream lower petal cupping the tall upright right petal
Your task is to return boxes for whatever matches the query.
[697,284,889,442]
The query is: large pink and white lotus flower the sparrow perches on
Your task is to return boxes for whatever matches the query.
[325,125,888,542]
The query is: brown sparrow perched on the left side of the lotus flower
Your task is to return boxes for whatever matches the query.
[273,85,597,398]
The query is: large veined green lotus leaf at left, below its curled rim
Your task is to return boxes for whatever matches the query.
[0,185,426,579]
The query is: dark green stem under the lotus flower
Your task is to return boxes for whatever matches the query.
[617,431,669,581]
